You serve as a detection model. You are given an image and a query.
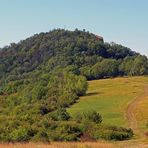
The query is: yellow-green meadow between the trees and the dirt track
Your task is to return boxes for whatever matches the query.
[68,77,148,126]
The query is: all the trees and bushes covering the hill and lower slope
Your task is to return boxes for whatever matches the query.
[0,29,148,142]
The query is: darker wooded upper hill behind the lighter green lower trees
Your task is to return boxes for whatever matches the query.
[0,29,148,80]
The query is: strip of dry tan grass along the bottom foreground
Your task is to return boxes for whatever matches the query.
[0,140,148,148]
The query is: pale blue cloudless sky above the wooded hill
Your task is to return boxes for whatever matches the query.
[0,0,148,55]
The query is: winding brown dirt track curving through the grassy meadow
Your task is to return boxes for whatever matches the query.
[126,86,148,139]
